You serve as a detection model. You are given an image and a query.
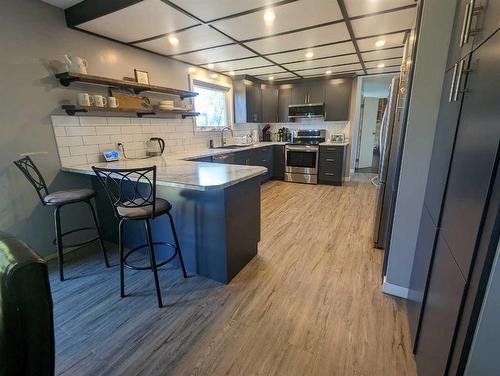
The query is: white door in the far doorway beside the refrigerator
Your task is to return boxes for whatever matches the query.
[358,97,379,168]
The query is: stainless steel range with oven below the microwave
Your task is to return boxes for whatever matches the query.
[285,129,326,184]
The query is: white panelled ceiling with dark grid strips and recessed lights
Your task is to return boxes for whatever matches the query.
[54,0,417,80]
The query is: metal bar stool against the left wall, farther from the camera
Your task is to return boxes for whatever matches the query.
[14,156,109,281]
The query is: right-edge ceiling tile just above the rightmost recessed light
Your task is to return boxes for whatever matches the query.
[352,8,417,38]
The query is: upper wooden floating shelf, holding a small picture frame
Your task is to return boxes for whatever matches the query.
[56,72,198,99]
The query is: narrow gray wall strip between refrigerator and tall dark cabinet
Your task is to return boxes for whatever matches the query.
[387,0,456,288]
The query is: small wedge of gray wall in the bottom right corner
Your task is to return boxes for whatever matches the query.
[465,242,500,376]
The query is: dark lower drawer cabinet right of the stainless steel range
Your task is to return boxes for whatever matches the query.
[318,145,346,185]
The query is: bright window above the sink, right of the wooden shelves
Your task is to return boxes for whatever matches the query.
[192,80,229,128]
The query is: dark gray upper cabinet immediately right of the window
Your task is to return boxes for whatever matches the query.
[233,80,262,124]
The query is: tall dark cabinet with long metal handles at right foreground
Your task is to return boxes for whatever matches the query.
[408,0,500,375]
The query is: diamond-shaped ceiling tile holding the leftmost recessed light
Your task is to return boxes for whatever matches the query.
[136,25,233,55]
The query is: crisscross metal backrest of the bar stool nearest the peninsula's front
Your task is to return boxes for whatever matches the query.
[92,166,156,219]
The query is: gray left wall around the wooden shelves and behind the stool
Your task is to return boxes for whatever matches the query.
[0,0,215,255]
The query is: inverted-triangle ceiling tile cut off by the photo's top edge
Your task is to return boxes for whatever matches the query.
[171,0,281,21]
